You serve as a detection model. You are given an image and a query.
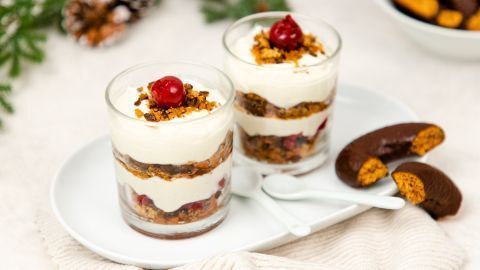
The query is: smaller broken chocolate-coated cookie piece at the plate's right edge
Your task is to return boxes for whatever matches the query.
[392,162,462,219]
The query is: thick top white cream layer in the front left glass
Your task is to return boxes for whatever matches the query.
[110,82,233,165]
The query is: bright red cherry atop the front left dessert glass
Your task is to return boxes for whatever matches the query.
[152,76,186,109]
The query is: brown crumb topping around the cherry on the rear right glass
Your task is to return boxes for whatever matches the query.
[252,31,325,66]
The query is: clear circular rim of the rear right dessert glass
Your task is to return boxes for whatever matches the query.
[222,11,343,70]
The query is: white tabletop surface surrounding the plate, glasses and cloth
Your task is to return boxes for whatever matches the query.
[0,0,480,269]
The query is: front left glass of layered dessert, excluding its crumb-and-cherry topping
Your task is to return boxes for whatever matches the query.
[106,62,234,239]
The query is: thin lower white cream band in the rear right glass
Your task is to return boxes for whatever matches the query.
[235,106,331,137]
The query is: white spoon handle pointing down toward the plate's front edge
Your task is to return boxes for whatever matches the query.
[253,192,311,236]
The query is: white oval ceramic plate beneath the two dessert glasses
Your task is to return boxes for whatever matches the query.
[50,86,417,268]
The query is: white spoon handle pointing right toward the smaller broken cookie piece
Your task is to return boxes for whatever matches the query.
[305,190,405,209]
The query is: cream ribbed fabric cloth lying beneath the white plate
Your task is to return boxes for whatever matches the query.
[37,205,464,270]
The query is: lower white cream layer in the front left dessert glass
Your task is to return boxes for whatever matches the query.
[115,155,232,212]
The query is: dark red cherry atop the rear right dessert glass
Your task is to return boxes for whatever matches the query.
[270,15,303,50]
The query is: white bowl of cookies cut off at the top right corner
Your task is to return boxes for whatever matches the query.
[377,0,480,60]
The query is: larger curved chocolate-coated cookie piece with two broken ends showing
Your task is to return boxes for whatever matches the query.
[335,123,445,187]
